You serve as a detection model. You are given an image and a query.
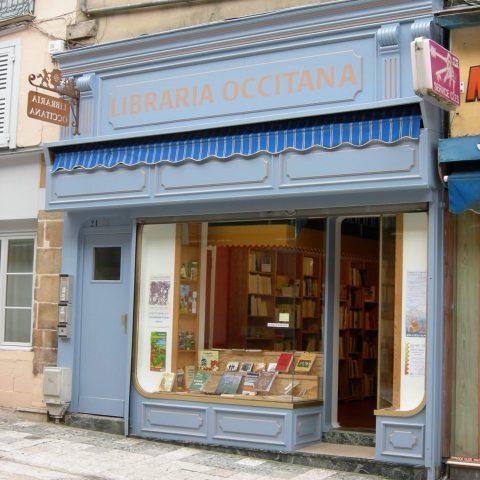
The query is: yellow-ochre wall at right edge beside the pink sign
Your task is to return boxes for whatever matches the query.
[450,27,480,137]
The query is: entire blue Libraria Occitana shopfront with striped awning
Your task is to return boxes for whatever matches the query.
[46,2,443,478]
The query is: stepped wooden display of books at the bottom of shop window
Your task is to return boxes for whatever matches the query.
[160,349,323,403]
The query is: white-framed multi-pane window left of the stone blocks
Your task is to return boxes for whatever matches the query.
[0,236,35,346]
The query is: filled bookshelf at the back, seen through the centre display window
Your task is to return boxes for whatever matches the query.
[244,247,323,351]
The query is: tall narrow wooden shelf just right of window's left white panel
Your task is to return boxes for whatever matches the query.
[172,223,201,372]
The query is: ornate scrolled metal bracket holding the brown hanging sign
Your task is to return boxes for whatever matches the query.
[28,68,80,135]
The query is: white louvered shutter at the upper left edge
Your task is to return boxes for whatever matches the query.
[0,46,15,147]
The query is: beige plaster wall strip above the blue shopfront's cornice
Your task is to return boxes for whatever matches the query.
[82,0,327,43]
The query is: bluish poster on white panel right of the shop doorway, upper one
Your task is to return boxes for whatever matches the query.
[405,271,427,337]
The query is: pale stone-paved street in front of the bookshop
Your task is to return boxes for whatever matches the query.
[0,410,380,480]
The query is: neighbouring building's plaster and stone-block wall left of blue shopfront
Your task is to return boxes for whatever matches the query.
[0,0,78,409]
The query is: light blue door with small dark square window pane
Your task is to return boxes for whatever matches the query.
[78,232,132,417]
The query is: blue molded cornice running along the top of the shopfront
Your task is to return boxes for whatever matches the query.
[54,0,432,75]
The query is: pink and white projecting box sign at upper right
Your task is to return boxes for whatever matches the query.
[411,37,460,110]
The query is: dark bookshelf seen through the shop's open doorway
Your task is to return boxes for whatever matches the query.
[338,259,378,400]
